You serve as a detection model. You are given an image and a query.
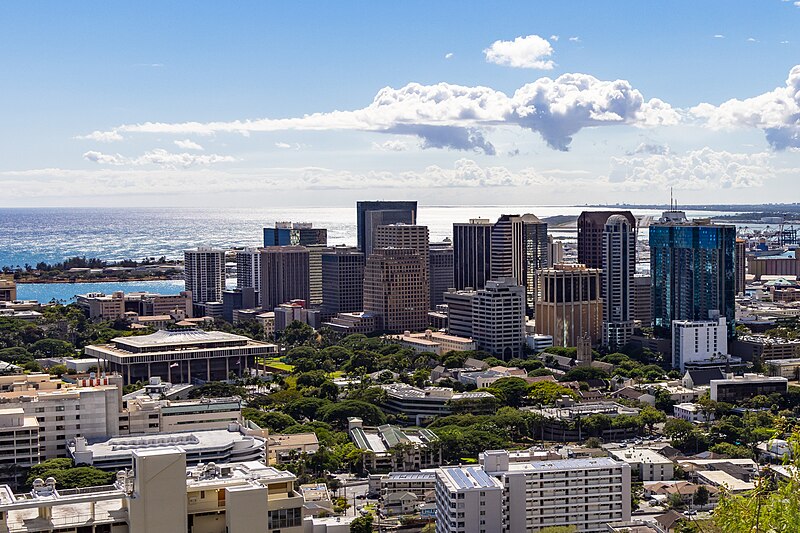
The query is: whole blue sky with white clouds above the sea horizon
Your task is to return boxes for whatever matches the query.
[0,0,800,207]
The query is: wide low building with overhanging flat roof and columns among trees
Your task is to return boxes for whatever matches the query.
[86,329,277,385]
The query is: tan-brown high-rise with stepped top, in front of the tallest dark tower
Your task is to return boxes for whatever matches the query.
[364,248,428,332]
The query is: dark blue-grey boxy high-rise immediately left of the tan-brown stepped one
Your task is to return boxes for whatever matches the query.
[321,246,364,317]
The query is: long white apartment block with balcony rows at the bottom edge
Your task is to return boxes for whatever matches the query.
[436,450,631,533]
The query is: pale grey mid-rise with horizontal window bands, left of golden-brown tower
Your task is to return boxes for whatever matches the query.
[472,279,525,361]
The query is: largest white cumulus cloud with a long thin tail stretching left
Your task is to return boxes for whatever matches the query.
[84,74,680,154]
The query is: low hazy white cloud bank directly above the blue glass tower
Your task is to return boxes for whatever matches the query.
[609,147,778,190]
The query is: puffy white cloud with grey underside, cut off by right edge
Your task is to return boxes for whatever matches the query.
[690,65,800,150]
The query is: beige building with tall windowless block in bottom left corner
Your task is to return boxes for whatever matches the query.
[0,447,303,533]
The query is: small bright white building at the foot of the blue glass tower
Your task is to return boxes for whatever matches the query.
[672,317,728,371]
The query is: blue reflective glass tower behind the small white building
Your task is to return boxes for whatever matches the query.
[650,211,736,337]
